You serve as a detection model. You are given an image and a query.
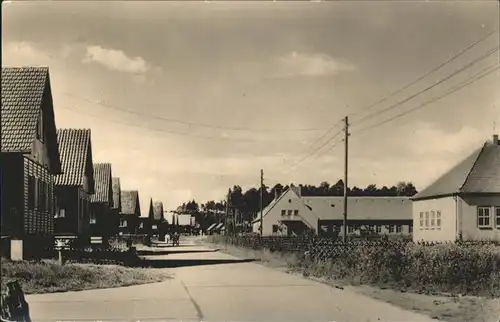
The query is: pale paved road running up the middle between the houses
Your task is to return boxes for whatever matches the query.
[27,245,433,322]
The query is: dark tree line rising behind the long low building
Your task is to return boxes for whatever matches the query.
[177,180,417,228]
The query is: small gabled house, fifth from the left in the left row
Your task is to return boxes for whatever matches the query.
[118,190,141,235]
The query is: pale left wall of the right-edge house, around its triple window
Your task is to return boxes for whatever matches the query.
[412,197,458,242]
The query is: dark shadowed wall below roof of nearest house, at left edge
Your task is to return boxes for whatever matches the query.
[0,153,24,237]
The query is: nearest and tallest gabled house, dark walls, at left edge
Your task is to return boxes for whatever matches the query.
[0,67,62,259]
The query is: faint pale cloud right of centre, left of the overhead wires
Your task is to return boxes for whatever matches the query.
[276,51,354,77]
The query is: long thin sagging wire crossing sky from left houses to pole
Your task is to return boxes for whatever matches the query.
[63,93,327,132]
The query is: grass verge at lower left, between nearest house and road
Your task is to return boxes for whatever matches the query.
[1,258,170,294]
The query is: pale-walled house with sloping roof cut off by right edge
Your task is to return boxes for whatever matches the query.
[413,135,500,241]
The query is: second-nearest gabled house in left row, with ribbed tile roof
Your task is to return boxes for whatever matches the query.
[55,129,95,246]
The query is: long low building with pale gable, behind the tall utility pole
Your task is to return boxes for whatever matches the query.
[253,185,413,236]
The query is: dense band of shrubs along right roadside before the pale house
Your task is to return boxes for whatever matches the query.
[212,236,500,296]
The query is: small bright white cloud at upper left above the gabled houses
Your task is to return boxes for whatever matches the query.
[83,46,151,74]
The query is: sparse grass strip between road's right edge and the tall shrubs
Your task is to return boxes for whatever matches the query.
[205,238,500,322]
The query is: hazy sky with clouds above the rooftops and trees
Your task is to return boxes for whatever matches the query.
[2,0,500,215]
